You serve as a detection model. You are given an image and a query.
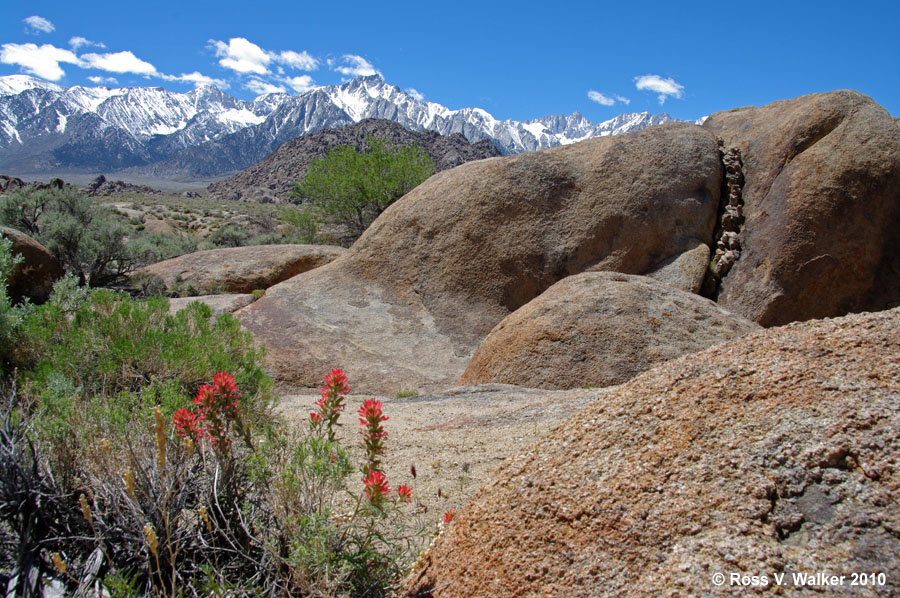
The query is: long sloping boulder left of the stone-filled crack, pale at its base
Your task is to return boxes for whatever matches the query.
[238,124,722,392]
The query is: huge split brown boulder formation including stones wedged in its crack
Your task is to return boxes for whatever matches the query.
[236,91,900,393]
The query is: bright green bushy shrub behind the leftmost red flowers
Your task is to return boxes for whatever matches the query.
[17,289,269,410]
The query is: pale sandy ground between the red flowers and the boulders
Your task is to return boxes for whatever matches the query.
[279,380,606,525]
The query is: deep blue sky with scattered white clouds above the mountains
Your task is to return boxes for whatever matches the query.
[0,0,900,122]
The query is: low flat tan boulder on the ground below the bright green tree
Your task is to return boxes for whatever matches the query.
[137,245,346,293]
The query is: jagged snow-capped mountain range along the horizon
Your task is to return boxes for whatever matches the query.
[0,75,674,178]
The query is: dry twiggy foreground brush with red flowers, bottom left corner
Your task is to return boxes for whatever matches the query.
[0,374,429,597]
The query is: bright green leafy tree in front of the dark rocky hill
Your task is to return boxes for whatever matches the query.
[292,136,434,237]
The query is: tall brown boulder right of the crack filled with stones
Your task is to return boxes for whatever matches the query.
[703,91,900,326]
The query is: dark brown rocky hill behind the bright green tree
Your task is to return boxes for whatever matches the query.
[209,119,500,203]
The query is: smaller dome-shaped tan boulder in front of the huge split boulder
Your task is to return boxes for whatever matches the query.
[458,272,760,389]
